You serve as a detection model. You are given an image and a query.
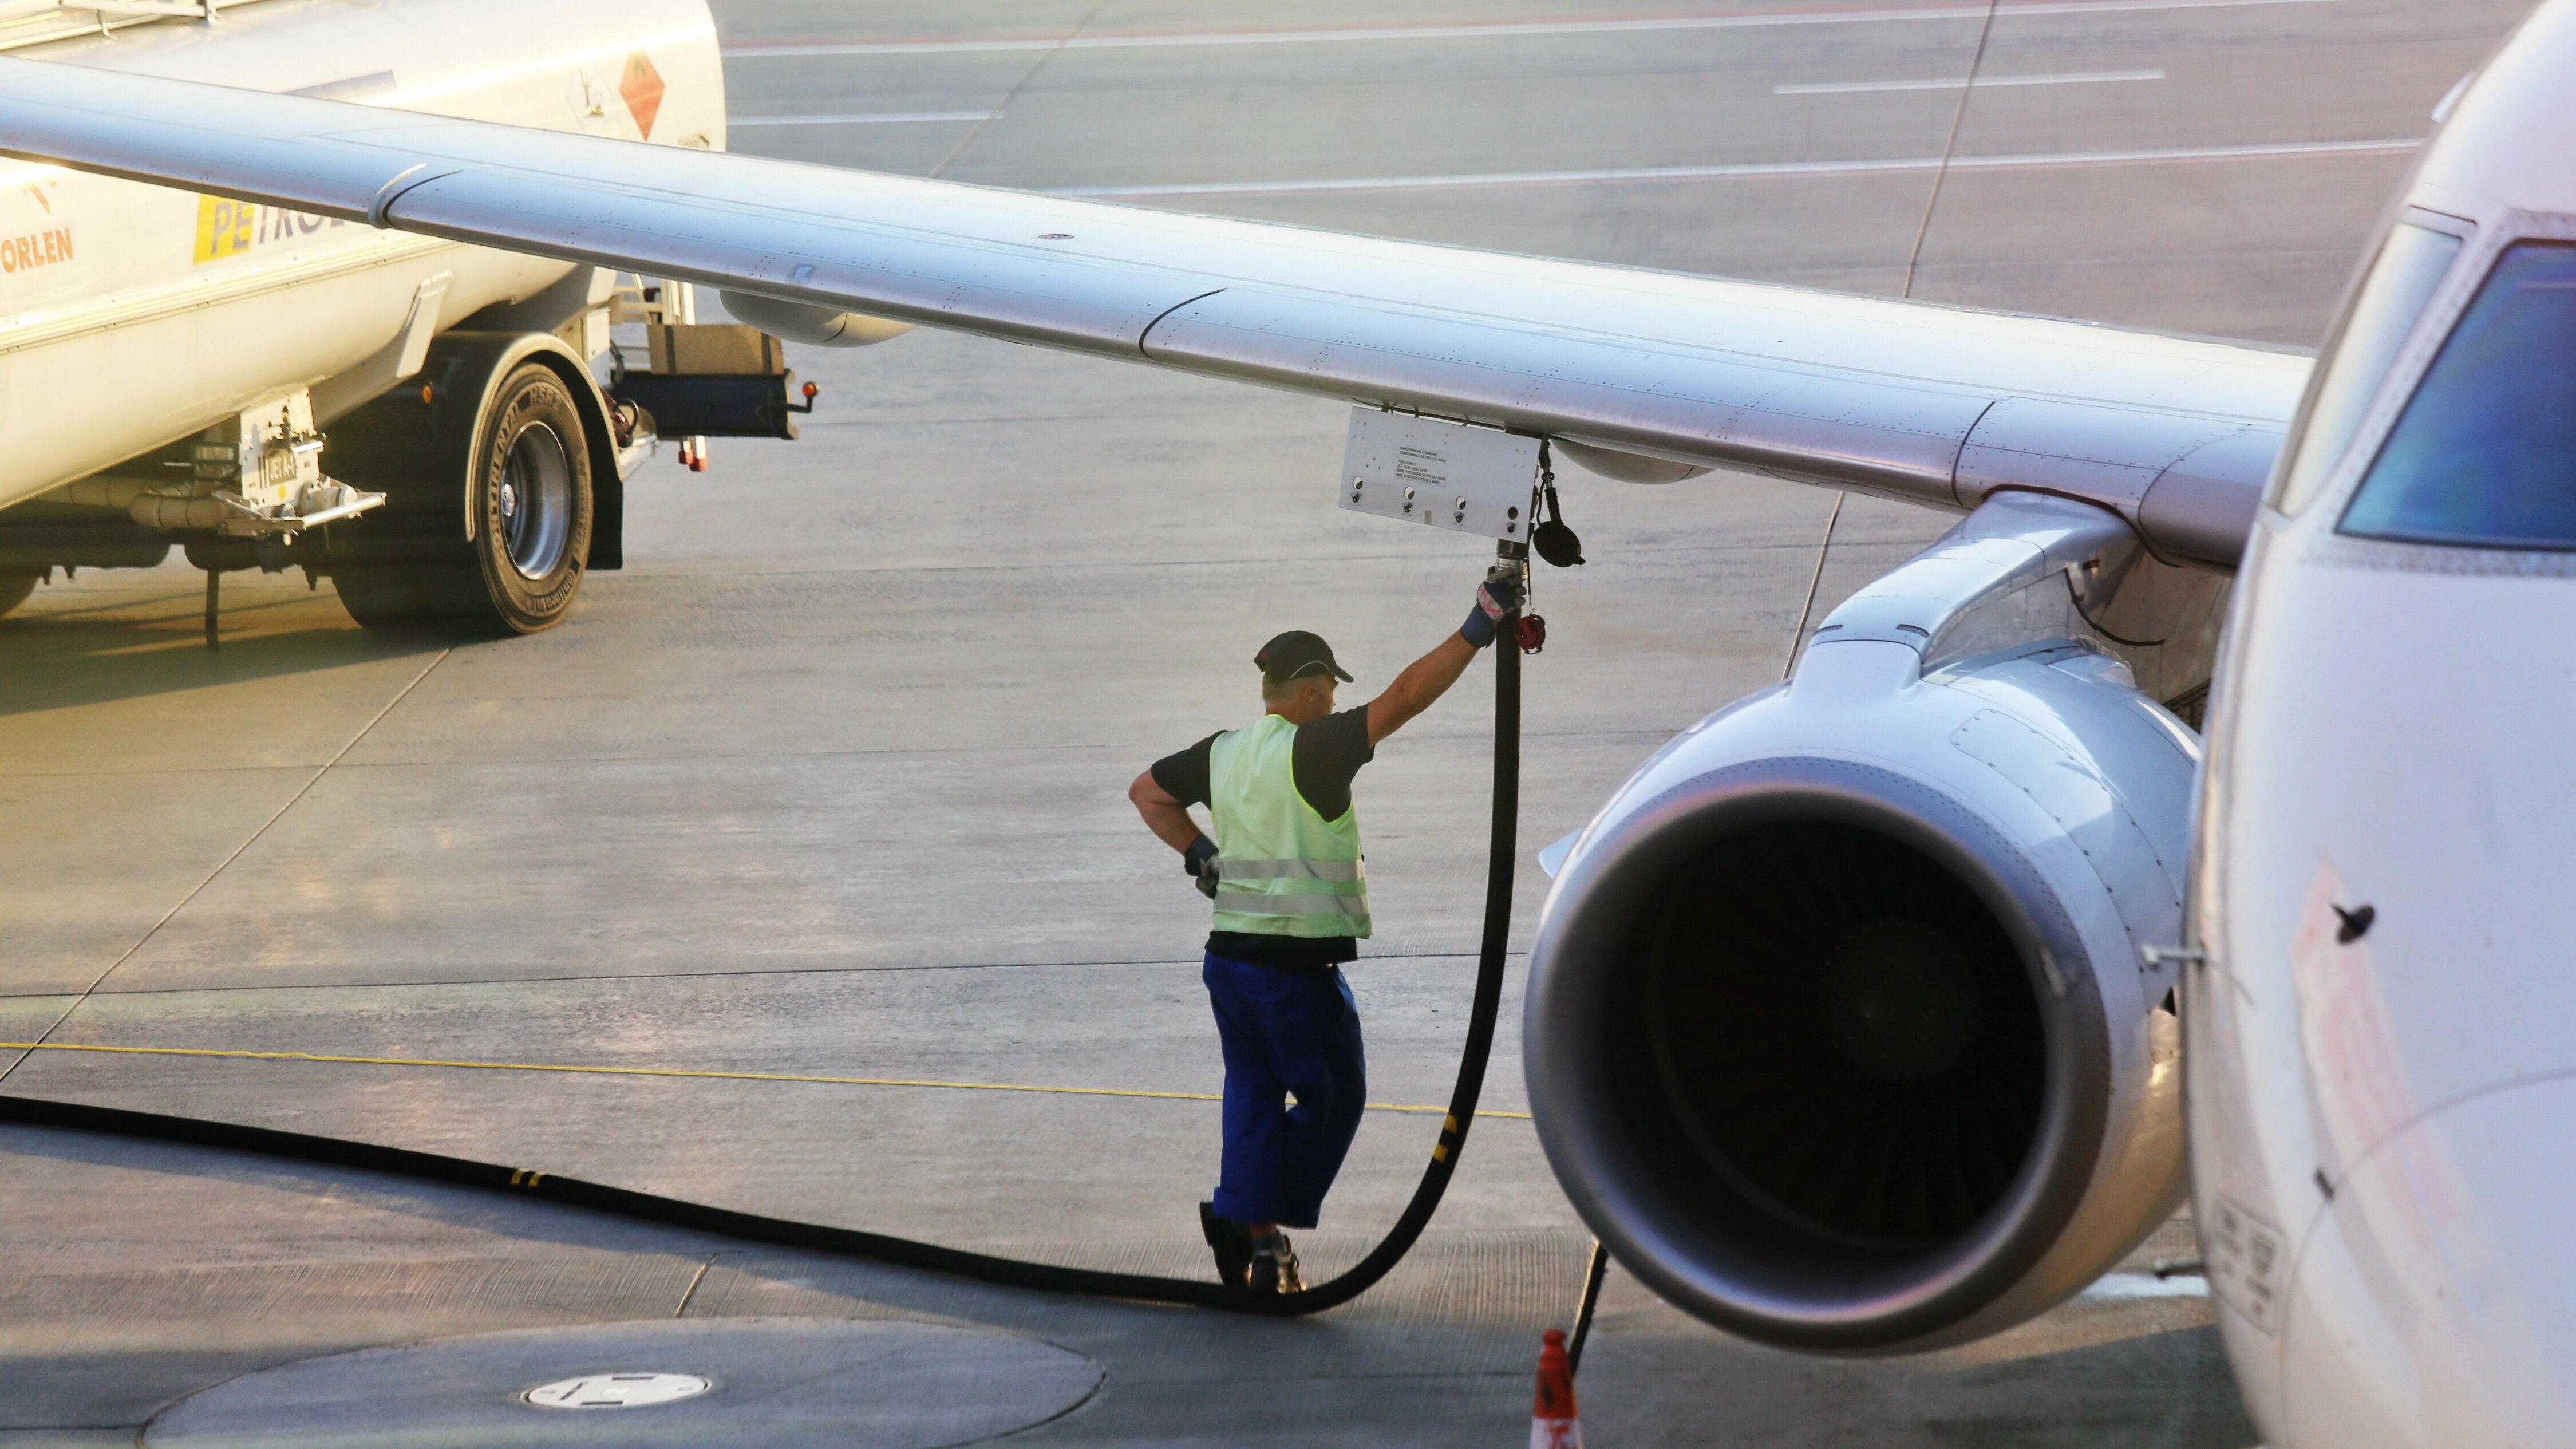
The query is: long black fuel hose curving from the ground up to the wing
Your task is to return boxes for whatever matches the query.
[0,567,1528,1317]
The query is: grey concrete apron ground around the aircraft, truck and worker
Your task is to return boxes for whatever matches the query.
[0,0,2524,1449]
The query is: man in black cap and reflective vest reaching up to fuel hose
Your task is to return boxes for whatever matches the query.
[1128,564,1520,1292]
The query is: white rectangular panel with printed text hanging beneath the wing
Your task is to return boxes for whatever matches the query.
[1342,408,1538,544]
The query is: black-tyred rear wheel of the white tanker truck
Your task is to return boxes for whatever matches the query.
[330,361,592,634]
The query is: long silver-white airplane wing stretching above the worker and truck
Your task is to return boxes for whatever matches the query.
[0,60,2308,567]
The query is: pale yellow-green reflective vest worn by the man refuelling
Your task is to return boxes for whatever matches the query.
[1208,714,1368,936]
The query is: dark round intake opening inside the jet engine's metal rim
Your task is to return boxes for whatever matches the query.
[1607,818,2050,1258]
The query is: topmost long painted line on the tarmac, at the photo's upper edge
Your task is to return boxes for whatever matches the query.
[724,0,2334,60]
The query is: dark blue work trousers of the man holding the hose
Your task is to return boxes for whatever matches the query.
[1200,954,1368,1227]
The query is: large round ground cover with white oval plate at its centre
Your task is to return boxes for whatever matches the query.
[144,1317,1100,1449]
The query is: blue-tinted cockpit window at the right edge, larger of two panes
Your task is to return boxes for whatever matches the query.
[2342,242,2576,549]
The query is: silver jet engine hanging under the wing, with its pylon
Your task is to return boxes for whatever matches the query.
[1525,489,2200,1353]
